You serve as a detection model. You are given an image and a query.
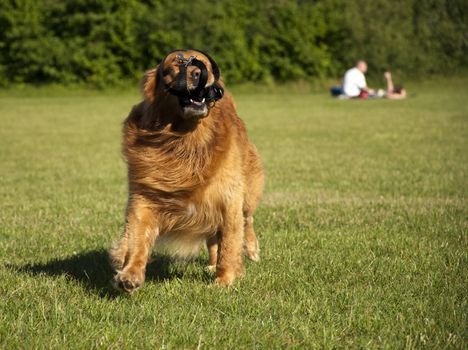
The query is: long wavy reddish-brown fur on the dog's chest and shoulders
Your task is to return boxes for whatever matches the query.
[124,106,243,243]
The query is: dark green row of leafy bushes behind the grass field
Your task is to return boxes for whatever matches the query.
[0,0,468,86]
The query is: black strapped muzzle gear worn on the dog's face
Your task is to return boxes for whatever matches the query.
[158,50,224,105]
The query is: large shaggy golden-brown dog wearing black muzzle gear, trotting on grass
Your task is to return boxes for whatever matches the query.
[110,50,263,293]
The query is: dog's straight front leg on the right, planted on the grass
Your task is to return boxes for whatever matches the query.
[215,199,244,286]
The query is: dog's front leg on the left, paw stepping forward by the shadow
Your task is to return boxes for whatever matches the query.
[114,207,157,293]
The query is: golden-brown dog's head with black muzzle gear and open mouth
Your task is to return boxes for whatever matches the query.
[144,50,224,119]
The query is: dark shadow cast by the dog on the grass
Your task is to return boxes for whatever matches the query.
[6,250,209,298]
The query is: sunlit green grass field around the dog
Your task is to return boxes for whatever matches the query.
[0,79,468,349]
